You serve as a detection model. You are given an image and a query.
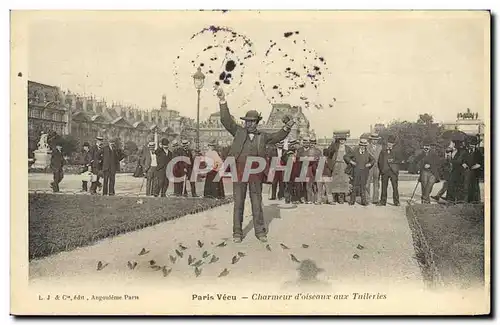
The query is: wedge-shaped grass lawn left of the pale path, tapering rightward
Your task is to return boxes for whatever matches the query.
[29,193,231,260]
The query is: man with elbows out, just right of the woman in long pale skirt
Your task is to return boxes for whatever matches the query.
[344,139,375,205]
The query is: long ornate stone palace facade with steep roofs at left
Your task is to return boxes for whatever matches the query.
[28,81,194,152]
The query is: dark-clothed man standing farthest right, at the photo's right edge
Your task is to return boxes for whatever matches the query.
[463,136,484,203]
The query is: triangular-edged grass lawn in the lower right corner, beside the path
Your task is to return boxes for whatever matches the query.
[406,204,484,288]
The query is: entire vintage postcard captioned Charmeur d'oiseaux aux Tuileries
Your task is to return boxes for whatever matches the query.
[11,10,491,315]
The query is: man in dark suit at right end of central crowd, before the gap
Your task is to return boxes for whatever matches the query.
[377,135,401,206]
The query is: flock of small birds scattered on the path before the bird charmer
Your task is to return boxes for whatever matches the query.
[97,240,364,278]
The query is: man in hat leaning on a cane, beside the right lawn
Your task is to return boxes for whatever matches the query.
[415,139,440,204]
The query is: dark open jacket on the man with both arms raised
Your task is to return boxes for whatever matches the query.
[220,103,290,160]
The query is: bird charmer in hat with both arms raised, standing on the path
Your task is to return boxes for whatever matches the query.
[217,88,295,243]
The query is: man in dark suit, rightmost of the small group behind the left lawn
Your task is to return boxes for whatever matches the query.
[102,140,125,196]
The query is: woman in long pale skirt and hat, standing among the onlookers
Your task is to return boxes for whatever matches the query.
[328,133,351,204]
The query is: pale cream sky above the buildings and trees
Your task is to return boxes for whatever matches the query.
[28,11,489,137]
